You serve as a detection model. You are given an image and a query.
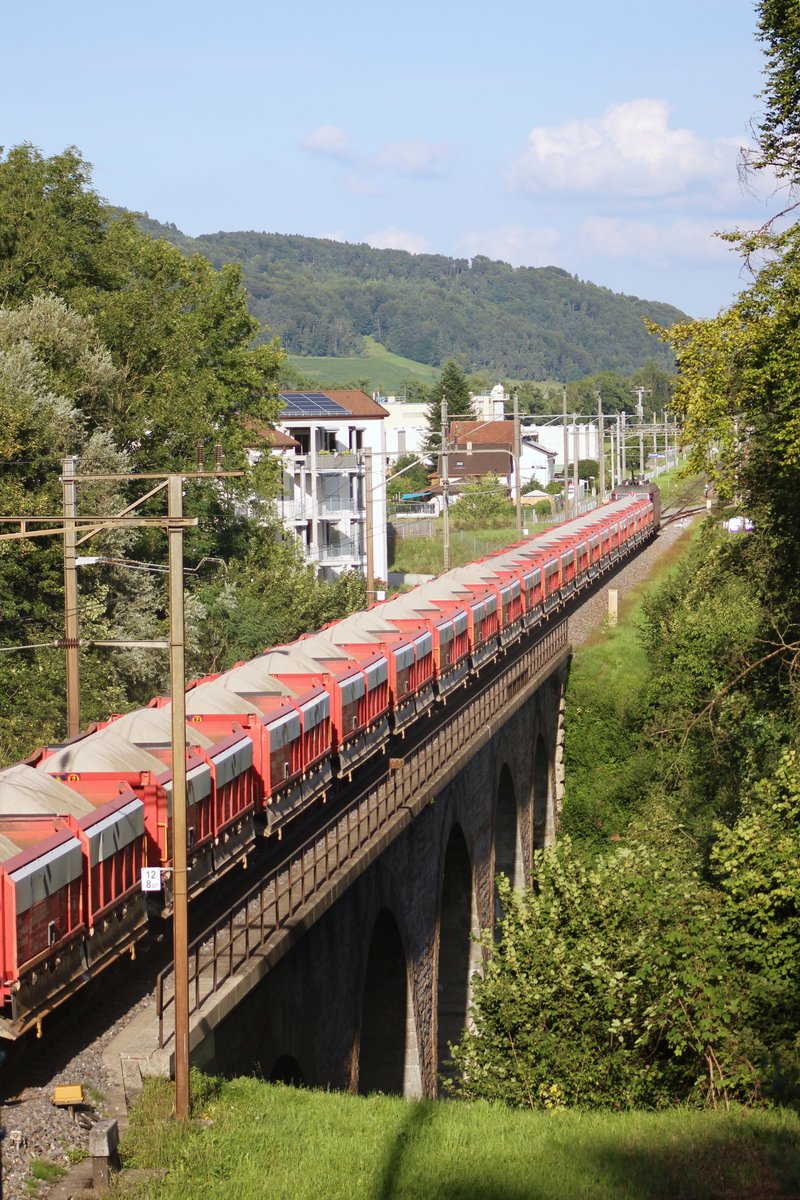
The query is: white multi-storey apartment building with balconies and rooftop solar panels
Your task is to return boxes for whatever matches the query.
[266,389,389,580]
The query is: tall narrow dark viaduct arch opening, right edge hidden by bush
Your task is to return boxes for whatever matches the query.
[437,824,479,1076]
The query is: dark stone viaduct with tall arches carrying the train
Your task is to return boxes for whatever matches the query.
[172,623,570,1097]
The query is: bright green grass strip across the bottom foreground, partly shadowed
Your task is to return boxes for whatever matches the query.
[121,1079,799,1200]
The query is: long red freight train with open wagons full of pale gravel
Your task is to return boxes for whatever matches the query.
[0,484,660,1038]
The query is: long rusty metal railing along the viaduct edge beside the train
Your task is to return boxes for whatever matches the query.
[156,620,567,1046]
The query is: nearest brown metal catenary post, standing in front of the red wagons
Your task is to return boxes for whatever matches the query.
[167,475,191,1121]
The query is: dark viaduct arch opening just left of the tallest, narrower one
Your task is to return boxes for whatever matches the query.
[357,908,421,1097]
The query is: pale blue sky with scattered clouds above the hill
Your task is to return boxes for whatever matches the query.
[0,0,780,317]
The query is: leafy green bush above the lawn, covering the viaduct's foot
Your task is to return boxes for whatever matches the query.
[455,839,763,1109]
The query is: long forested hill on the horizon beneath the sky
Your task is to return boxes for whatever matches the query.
[142,218,684,379]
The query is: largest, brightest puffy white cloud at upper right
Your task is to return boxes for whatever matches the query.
[510,100,738,197]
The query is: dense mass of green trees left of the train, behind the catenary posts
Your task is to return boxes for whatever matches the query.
[0,145,363,762]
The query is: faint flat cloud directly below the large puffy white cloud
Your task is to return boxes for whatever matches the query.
[577,217,730,268]
